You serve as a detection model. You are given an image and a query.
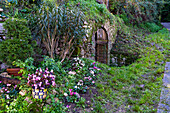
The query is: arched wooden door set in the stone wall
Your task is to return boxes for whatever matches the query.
[95,28,108,64]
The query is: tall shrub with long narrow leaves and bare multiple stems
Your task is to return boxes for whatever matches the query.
[29,1,85,61]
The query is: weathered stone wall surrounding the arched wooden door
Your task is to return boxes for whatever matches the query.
[81,20,117,64]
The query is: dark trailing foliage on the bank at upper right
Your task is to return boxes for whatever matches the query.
[110,0,162,25]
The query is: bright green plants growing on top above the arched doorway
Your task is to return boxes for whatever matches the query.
[67,0,115,24]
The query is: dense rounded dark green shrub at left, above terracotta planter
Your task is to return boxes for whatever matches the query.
[0,18,36,65]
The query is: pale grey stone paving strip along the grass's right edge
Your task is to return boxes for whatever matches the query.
[157,62,170,113]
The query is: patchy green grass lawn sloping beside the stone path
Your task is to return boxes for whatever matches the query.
[93,29,170,112]
